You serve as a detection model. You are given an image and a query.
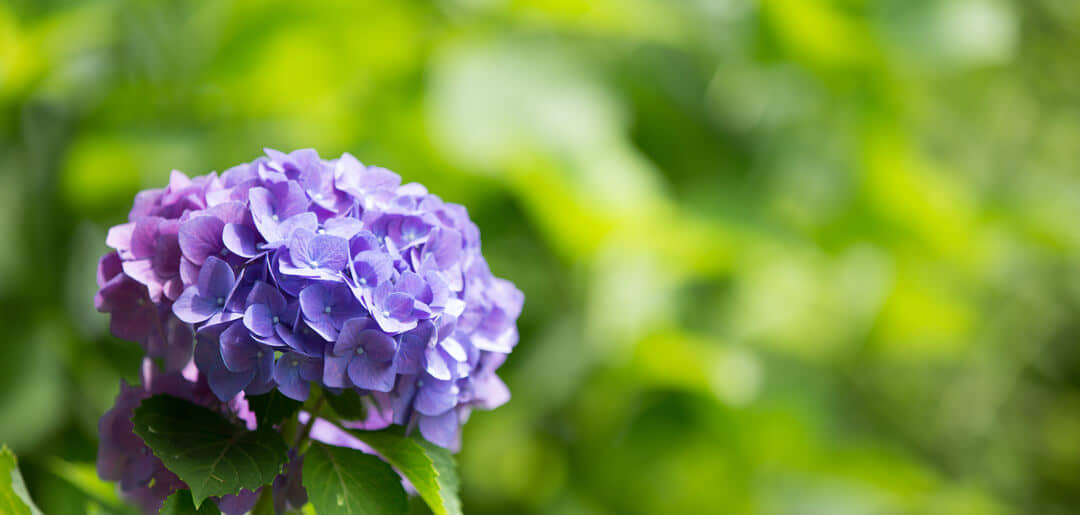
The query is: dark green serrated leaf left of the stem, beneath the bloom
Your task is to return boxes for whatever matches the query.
[132,395,288,506]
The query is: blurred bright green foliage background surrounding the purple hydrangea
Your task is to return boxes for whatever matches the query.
[0,0,1080,515]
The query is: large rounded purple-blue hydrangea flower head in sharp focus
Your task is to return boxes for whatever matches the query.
[95,146,524,448]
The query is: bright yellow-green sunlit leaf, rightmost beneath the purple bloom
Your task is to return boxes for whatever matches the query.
[350,430,461,515]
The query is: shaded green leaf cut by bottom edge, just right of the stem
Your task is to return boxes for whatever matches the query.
[301,443,408,515]
